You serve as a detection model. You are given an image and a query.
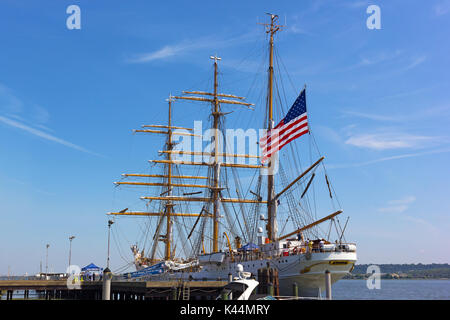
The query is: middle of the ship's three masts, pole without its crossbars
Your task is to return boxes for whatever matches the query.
[210,55,222,252]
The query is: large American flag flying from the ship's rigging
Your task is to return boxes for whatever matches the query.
[259,89,309,163]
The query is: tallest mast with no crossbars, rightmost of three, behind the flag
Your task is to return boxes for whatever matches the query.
[265,14,282,242]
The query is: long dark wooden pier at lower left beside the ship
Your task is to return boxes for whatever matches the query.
[0,280,228,301]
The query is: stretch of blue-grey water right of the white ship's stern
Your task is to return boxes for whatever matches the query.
[332,279,450,300]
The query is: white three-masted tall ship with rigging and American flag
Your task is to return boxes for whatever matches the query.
[108,14,356,297]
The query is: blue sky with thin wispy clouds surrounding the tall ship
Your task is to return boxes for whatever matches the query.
[0,0,450,274]
